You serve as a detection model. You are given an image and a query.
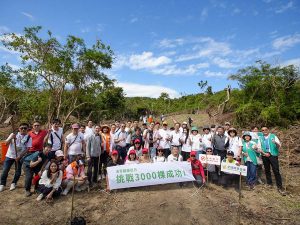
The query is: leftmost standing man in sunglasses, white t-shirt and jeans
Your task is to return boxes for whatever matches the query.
[0,123,32,192]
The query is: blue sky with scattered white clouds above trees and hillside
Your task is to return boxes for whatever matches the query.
[0,0,300,97]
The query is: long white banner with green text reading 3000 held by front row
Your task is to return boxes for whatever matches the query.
[107,162,195,190]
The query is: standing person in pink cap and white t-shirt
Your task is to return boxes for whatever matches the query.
[64,123,86,163]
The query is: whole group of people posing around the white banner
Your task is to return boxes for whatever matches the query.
[0,119,284,201]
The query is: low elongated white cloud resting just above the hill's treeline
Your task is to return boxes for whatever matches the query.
[117,82,180,98]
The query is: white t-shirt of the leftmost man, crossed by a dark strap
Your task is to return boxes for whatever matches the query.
[5,132,32,159]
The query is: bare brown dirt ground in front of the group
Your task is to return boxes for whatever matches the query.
[0,168,300,225]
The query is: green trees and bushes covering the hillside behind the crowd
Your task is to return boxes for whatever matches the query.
[0,27,300,126]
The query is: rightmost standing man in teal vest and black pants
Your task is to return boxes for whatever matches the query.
[260,126,285,195]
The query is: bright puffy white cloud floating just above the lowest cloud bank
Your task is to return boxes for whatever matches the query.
[128,52,172,70]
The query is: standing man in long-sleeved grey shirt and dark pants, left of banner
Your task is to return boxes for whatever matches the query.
[86,126,102,187]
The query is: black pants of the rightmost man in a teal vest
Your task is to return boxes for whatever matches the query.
[262,155,282,188]
